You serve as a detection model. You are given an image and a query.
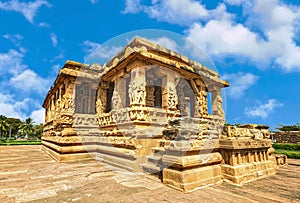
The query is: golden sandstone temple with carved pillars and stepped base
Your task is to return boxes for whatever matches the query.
[42,38,276,191]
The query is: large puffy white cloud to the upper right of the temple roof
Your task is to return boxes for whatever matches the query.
[186,20,267,61]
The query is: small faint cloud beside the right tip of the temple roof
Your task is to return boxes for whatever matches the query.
[222,72,258,98]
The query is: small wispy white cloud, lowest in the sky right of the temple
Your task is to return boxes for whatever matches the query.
[245,99,283,118]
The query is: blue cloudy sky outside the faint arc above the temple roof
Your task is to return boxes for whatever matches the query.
[0,0,300,128]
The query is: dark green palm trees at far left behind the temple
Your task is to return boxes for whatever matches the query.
[0,115,43,139]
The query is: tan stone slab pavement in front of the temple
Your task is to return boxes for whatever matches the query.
[0,146,300,203]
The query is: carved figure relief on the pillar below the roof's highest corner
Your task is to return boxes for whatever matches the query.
[129,81,146,105]
